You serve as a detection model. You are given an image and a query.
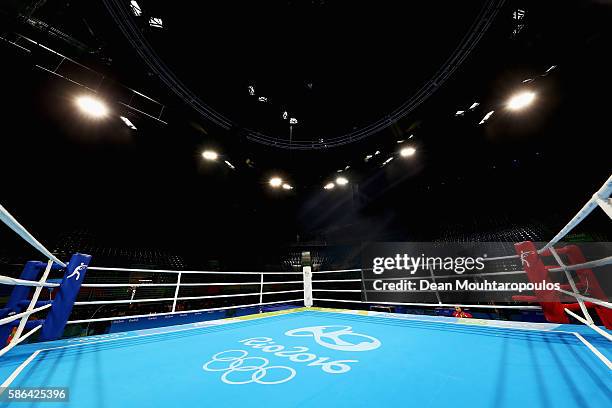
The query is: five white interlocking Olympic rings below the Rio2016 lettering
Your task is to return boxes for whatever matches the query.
[202,350,296,385]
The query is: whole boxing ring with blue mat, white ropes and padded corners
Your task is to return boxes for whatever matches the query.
[0,177,612,407]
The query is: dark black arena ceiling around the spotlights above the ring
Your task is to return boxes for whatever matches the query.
[0,0,612,262]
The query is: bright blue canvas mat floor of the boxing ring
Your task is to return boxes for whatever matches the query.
[0,309,612,408]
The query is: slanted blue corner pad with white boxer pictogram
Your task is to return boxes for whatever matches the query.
[40,254,91,341]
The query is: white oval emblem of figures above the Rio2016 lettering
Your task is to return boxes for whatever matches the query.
[285,326,381,351]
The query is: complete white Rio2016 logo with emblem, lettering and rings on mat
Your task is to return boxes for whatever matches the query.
[202,325,381,384]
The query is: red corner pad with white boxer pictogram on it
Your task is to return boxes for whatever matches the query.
[514,241,569,323]
